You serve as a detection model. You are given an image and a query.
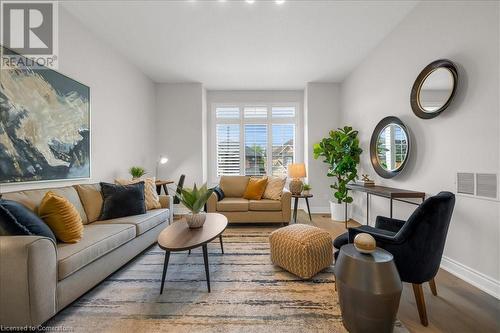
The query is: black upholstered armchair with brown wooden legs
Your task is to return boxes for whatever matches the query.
[333,192,455,326]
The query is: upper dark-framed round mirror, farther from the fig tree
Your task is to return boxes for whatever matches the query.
[410,59,458,119]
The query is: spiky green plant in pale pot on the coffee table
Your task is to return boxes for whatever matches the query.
[175,183,214,229]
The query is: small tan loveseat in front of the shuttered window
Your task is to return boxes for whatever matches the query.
[207,176,292,224]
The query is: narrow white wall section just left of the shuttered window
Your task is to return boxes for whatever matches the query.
[156,83,205,187]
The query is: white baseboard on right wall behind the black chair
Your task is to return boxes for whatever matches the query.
[441,256,500,299]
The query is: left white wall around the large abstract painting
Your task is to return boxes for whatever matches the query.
[0,6,156,192]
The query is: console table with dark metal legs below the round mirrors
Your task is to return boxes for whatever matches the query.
[346,184,425,224]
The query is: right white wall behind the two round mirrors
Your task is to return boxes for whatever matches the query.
[341,1,500,296]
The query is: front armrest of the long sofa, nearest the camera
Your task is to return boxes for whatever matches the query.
[0,236,57,326]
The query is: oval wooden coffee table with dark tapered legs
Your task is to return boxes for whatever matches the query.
[158,213,227,294]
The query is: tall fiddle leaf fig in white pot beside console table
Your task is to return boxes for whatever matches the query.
[313,126,363,221]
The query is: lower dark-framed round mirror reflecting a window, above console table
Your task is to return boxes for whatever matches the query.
[370,117,411,178]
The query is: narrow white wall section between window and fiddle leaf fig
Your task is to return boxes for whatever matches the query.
[304,82,343,213]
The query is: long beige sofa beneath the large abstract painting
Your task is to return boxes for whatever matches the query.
[0,185,173,326]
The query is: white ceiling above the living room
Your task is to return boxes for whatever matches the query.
[63,0,417,90]
